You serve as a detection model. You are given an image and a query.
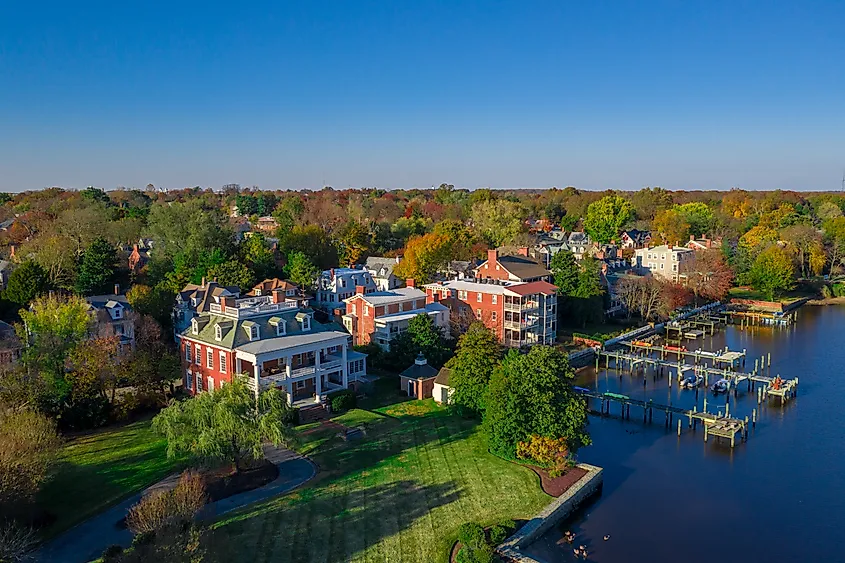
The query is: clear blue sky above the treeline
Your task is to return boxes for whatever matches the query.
[0,0,845,191]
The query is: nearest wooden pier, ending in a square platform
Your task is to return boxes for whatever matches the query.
[579,390,757,448]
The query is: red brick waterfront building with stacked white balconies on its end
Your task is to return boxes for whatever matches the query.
[425,280,557,347]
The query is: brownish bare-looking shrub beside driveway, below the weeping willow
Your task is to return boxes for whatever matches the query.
[126,471,206,535]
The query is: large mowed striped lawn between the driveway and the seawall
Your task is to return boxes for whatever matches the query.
[215,400,551,563]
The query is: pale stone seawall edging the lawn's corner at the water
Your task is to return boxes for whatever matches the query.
[496,463,603,563]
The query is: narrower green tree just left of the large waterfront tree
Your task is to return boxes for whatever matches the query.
[446,322,502,413]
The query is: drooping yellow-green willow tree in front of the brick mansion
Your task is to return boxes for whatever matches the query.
[153,378,294,473]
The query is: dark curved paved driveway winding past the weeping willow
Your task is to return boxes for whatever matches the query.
[35,448,317,563]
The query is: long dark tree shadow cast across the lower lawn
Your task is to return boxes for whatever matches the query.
[216,480,461,563]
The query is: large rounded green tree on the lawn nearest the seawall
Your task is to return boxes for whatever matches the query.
[484,346,590,459]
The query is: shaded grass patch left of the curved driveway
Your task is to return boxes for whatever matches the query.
[37,421,181,538]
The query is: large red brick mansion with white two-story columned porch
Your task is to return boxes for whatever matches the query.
[177,291,367,406]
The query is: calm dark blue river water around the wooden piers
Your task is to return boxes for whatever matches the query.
[529,306,845,563]
